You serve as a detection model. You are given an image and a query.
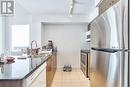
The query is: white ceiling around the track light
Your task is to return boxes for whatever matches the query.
[16,0,94,15]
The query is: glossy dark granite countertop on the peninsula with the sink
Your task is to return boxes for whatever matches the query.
[0,54,51,80]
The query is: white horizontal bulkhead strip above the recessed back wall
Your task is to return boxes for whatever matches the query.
[42,15,89,23]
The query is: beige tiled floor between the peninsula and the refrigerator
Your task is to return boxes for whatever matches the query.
[51,69,90,87]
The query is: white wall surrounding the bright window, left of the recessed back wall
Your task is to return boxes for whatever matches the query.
[5,2,42,49]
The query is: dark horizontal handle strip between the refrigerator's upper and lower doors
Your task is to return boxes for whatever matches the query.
[91,47,130,53]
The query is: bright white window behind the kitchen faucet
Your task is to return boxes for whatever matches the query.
[12,25,29,50]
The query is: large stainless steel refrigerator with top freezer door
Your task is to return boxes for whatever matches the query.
[90,0,129,87]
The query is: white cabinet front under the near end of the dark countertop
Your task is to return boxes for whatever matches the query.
[24,63,46,87]
